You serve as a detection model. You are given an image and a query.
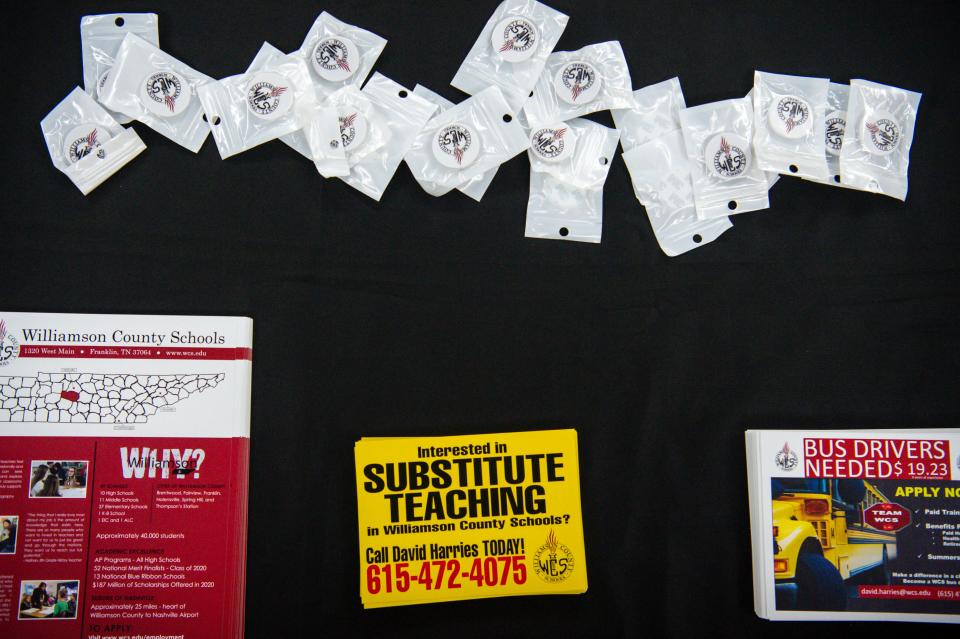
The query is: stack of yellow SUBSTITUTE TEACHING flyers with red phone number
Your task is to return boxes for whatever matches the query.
[355,429,587,608]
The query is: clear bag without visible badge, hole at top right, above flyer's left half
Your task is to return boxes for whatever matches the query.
[340,73,437,201]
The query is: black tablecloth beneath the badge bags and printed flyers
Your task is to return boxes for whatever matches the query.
[0,0,960,638]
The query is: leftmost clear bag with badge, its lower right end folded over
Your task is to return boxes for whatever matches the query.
[40,87,147,195]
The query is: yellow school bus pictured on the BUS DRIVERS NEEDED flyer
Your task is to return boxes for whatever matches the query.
[771,478,897,610]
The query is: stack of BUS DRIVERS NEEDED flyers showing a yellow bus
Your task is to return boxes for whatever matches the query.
[746,429,960,623]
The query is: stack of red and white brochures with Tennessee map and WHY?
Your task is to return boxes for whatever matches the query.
[0,311,253,639]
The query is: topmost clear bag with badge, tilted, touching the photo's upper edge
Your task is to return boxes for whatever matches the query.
[450,0,570,114]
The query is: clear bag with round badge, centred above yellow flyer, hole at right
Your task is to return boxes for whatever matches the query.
[404,87,530,196]
